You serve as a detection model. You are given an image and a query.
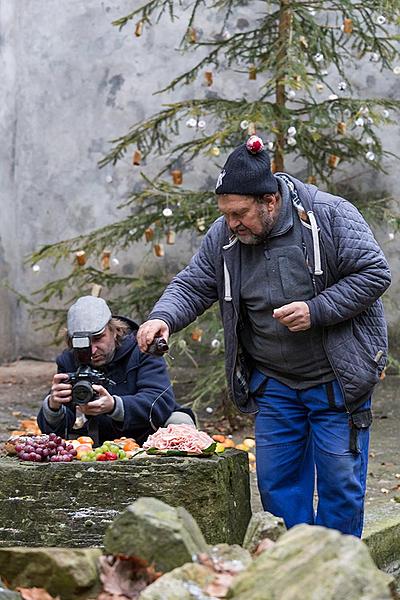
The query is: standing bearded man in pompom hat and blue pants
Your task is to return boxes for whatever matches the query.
[138,136,390,537]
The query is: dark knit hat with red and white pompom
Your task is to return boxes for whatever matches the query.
[215,135,278,196]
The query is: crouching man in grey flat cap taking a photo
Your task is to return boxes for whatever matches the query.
[38,296,194,444]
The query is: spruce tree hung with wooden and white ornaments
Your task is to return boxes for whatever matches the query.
[30,0,400,412]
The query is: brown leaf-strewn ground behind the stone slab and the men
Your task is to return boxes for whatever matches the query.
[0,360,400,522]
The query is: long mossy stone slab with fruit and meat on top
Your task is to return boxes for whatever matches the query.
[0,450,251,547]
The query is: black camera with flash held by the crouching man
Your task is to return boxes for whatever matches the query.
[67,332,115,404]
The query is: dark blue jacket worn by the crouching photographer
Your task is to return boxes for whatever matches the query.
[38,317,195,444]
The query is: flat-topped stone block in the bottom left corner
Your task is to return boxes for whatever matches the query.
[0,547,101,600]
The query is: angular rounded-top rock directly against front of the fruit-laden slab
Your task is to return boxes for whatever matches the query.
[104,498,207,572]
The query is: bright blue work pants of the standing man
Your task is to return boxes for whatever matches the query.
[250,370,370,537]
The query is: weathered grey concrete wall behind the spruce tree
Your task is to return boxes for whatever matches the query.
[0,0,400,361]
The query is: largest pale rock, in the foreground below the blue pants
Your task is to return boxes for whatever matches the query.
[227,525,395,600]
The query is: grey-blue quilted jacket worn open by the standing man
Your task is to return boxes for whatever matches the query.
[149,174,390,413]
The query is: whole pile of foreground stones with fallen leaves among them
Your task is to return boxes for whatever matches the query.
[0,498,398,600]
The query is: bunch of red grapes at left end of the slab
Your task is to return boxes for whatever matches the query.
[15,433,76,462]
